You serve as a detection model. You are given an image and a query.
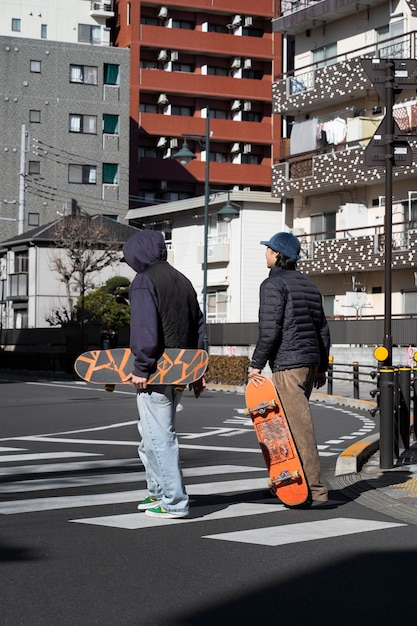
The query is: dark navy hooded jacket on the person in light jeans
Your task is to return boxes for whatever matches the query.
[123,230,204,378]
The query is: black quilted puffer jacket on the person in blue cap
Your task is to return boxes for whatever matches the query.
[251,267,330,372]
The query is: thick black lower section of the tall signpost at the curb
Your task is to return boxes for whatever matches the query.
[379,367,394,469]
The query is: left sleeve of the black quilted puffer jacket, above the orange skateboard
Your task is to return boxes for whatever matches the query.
[251,278,286,370]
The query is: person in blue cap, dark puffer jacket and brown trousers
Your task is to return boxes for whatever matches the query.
[248,232,330,506]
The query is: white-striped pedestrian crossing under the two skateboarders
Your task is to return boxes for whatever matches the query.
[0,448,404,547]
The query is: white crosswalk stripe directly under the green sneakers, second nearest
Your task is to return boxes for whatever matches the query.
[70,502,288,530]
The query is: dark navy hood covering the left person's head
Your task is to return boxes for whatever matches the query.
[123,230,167,272]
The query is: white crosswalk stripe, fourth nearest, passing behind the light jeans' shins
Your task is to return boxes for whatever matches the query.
[0,465,262,493]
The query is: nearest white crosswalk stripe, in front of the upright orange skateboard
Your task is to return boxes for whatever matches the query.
[203,517,406,547]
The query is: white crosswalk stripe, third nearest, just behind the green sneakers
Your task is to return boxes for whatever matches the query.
[0,478,266,515]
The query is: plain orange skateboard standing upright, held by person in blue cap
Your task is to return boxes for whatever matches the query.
[245,378,309,506]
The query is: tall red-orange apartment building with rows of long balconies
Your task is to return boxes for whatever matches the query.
[114,0,281,208]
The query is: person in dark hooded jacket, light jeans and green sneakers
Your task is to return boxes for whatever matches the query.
[123,230,205,518]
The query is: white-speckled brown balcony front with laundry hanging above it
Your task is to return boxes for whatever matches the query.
[272,138,417,198]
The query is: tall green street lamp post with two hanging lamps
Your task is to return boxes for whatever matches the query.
[173,108,238,350]
